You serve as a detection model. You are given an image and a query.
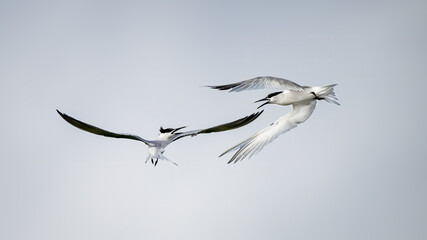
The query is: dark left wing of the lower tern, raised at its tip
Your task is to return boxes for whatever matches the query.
[56,109,155,146]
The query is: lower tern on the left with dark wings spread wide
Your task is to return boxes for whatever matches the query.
[56,110,263,166]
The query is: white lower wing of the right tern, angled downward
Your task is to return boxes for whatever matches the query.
[220,100,316,163]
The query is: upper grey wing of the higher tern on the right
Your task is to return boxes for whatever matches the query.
[208,76,303,92]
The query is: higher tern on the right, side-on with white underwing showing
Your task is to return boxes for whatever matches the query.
[207,76,340,163]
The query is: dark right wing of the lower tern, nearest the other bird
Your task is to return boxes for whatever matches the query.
[172,110,264,141]
